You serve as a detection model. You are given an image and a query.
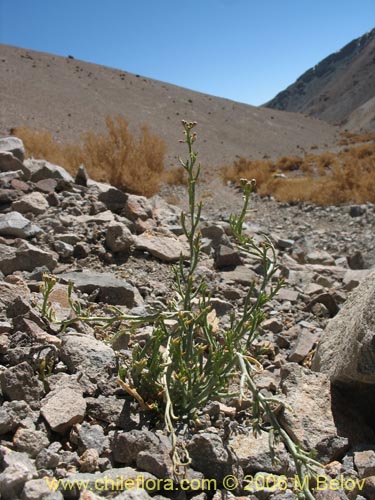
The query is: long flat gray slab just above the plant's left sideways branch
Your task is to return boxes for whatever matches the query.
[59,272,140,307]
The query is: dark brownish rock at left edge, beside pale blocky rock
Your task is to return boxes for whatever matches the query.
[0,361,43,408]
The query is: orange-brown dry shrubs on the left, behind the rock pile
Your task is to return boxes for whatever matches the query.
[14,116,166,196]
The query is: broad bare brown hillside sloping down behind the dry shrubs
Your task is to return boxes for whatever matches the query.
[0,45,336,166]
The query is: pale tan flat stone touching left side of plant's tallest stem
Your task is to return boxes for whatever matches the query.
[135,231,186,262]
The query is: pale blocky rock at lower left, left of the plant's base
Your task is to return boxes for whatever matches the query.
[41,388,86,434]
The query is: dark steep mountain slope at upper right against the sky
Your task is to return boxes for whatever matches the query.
[265,29,375,130]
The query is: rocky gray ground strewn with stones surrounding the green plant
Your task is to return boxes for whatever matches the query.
[0,138,375,500]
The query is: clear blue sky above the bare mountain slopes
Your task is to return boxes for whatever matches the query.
[0,0,375,105]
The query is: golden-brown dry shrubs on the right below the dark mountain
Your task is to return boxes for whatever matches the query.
[223,134,375,205]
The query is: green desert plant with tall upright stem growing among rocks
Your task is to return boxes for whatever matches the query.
[39,121,320,500]
